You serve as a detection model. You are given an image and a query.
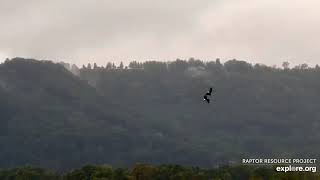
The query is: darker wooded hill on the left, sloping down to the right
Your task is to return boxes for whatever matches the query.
[0,58,151,169]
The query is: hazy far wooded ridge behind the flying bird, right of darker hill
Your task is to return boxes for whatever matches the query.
[80,58,320,165]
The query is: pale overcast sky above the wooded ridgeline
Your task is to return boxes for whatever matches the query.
[0,0,320,65]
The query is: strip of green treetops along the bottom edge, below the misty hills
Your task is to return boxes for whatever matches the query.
[0,164,320,180]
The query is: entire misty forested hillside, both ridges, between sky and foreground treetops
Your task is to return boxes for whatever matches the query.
[0,58,320,169]
